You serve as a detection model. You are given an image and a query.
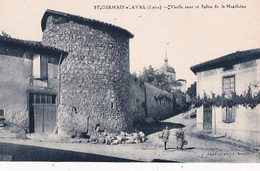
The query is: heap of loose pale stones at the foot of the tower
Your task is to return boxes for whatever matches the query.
[89,131,146,145]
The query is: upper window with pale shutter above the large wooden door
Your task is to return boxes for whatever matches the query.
[33,55,48,79]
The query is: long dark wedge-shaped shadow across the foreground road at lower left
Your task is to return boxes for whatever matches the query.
[0,143,138,162]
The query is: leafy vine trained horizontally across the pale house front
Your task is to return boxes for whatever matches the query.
[192,88,260,109]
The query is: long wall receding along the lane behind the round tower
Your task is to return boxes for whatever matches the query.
[129,78,175,125]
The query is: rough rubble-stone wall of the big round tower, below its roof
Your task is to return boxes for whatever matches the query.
[42,15,132,133]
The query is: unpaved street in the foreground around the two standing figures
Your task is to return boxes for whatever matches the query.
[0,111,260,163]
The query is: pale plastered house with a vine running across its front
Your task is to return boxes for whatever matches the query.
[191,49,260,145]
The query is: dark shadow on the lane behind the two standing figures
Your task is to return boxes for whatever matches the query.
[138,122,185,135]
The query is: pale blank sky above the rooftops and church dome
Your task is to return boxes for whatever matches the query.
[0,0,260,86]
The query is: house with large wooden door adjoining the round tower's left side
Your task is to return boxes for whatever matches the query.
[0,36,66,133]
